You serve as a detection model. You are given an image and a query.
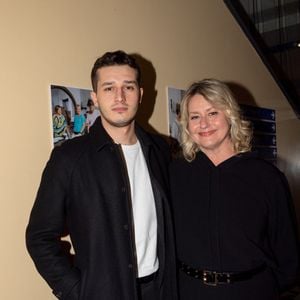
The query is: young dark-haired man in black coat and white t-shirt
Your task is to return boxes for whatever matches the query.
[26,51,177,300]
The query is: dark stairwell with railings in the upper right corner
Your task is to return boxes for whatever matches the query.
[224,0,300,119]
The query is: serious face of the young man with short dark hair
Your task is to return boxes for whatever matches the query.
[91,65,143,128]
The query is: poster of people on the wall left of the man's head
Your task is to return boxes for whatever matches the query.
[51,85,100,146]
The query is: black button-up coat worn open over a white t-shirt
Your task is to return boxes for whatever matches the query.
[26,118,177,300]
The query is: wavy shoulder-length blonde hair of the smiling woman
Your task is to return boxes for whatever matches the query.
[180,79,252,161]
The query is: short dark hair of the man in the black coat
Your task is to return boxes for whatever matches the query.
[91,50,141,92]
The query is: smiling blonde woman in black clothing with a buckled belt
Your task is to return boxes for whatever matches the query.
[170,79,299,300]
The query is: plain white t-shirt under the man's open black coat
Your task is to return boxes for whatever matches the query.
[122,142,158,277]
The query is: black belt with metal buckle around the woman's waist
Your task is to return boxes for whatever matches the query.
[178,261,266,286]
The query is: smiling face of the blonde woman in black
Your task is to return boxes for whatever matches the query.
[188,94,232,154]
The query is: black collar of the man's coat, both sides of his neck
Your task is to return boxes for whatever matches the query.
[88,117,152,151]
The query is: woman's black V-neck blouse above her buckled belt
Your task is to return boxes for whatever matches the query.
[170,152,299,288]
